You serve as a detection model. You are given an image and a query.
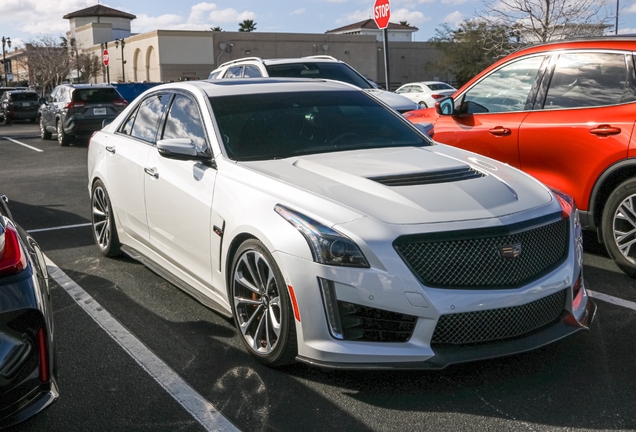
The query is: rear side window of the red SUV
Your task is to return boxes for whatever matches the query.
[544,53,636,109]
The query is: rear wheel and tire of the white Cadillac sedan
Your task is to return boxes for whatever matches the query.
[91,180,121,257]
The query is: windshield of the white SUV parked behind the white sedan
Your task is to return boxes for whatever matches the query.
[266,61,375,89]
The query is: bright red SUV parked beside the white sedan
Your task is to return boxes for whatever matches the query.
[405,37,636,277]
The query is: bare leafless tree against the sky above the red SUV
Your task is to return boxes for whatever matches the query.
[477,0,610,45]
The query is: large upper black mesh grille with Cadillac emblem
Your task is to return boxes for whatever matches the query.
[394,219,569,288]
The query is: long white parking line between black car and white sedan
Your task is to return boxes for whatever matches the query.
[46,257,239,432]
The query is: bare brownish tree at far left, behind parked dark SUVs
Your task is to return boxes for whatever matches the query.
[16,36,70,95]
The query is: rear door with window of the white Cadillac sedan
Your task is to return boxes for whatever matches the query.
[103,93,170,245]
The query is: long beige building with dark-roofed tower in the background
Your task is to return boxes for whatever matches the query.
[64,5,449,90]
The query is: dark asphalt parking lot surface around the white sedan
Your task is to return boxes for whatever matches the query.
[0,123,636,431]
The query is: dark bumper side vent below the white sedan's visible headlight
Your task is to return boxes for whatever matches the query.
[338,301,417,342]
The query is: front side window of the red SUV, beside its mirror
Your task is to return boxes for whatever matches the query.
[459,56,544,114]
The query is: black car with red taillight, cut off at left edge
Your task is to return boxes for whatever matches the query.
[0,196,59,428]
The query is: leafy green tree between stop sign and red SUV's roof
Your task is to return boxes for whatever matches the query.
[426,20,514,86]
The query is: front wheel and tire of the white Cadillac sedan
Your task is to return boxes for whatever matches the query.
[230,240,298,367]
